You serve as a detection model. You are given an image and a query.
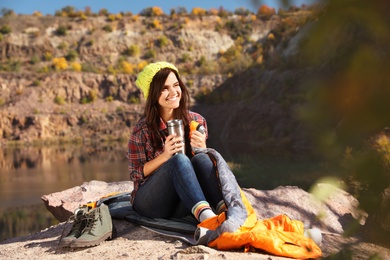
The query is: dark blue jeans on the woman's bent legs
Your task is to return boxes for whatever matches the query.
[133,153,223,218]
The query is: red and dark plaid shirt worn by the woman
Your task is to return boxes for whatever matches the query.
[127,111,208,202]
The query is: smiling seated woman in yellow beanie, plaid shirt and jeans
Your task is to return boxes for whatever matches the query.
[128,62,226,222]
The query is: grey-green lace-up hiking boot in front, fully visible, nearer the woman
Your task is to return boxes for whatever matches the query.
[70,204,112,248]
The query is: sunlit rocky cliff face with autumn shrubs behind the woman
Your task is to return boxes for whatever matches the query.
[0,10,310,145]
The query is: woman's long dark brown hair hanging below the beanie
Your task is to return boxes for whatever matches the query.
[144,68,190,149]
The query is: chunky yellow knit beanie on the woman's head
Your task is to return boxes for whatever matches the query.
[135,61,179,99]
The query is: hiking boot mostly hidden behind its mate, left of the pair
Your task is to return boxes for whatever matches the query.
[59,206,88,247]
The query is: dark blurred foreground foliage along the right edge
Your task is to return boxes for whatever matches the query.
[253,0,390,248]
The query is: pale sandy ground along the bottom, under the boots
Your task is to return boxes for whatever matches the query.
[0,220,390,260]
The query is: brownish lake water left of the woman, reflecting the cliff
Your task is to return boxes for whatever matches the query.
[0,143,128,241]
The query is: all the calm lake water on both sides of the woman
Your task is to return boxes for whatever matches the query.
[0,143,328,241]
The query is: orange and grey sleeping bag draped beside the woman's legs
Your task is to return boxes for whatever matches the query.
[198,149,322,259]
